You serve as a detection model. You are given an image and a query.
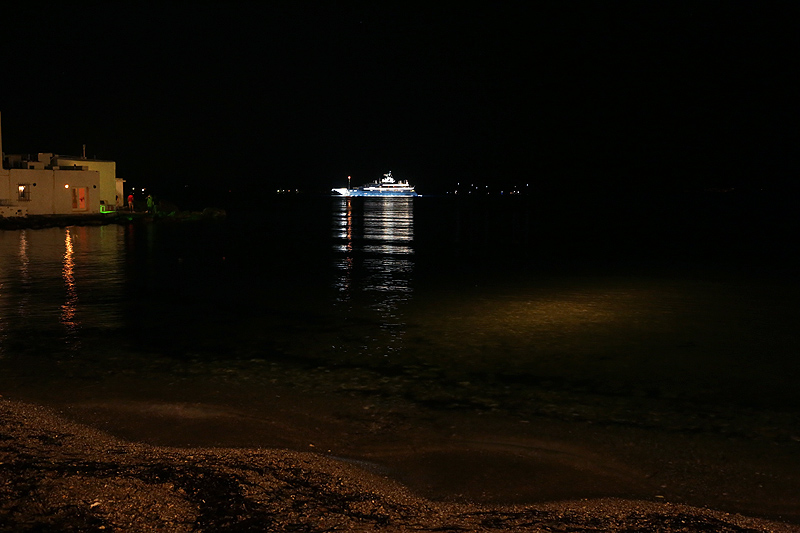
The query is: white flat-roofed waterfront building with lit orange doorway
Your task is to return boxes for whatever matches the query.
[0,111,122,217]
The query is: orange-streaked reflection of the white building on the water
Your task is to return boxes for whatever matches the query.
[0,226,124,350]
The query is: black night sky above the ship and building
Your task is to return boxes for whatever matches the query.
[0,1,800,200]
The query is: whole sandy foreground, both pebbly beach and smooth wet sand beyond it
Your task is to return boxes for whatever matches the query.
[0,396,800,532]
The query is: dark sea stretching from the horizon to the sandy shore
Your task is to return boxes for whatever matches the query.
[0,193,800,502]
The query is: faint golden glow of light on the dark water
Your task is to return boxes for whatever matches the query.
[413,280,681,375]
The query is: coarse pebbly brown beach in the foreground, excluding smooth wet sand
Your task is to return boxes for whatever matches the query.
[0,397,800,532]
